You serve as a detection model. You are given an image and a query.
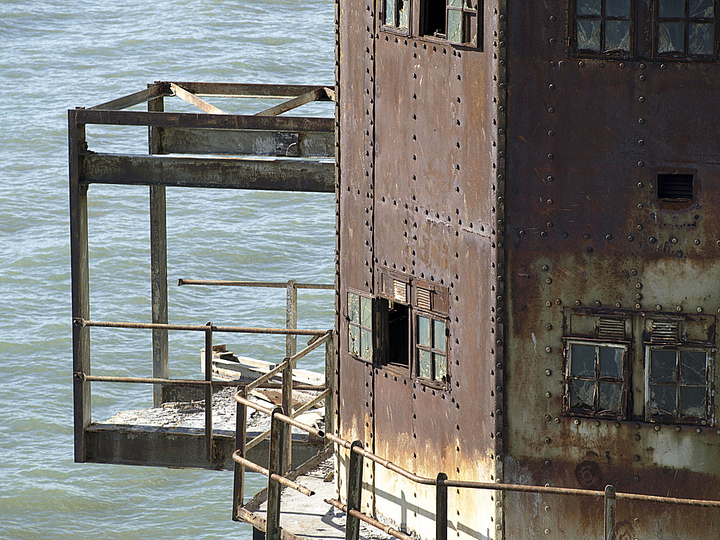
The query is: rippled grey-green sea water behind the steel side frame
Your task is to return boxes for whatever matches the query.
[0,0,334,540]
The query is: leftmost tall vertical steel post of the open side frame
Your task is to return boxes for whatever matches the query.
[68,110,92,462]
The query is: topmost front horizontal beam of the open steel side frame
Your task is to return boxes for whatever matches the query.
[74,109,335,131]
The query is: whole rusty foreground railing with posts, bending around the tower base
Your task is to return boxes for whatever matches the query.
[233,391,720,540]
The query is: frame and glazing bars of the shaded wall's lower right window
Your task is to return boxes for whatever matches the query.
[645,343,715,426]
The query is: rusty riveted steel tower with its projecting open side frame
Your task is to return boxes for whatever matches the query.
[70,0,720,540]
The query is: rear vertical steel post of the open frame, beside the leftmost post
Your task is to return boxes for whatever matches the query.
[148,89,170,407]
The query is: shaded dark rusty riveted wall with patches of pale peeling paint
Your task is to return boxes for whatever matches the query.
[505,0,720,538]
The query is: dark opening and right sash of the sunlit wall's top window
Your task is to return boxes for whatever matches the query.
[420,0,482,47]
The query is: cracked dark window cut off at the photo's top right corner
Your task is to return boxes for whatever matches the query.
[655,0,715,57]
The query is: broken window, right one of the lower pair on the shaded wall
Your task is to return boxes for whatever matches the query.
[645,347,710,424]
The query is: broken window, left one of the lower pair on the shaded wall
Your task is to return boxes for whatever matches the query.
[565,341,628,419]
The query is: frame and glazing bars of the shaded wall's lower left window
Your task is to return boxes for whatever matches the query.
[563,337,631,420]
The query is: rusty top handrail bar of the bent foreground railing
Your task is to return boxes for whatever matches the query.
[235,394,720,508]
